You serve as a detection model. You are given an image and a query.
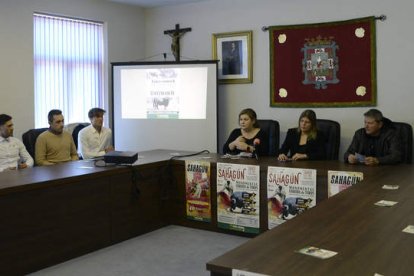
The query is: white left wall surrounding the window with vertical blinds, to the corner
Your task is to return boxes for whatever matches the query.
[0,0,144,138]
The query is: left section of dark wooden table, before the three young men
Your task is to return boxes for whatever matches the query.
[0,150,175,275]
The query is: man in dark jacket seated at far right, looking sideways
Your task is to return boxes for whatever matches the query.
[344,109,402,165]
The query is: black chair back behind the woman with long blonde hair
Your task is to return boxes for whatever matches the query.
[316,119,341,160]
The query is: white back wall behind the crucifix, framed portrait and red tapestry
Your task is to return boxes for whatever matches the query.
[145,0,414,156]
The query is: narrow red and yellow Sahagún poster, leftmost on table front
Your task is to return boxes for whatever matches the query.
[185,160,211,222]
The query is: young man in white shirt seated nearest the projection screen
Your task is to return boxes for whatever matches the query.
[78,108,114,159]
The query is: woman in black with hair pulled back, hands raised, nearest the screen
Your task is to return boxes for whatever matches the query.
[223,108,269,156]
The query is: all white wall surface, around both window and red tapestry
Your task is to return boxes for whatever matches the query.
[0,0,414,158]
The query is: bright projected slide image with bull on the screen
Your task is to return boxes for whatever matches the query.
[120,67,208,119]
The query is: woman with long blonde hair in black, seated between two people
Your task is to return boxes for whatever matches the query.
[277,109,326,161]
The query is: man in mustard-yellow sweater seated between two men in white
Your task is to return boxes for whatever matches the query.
[35,109,79,166]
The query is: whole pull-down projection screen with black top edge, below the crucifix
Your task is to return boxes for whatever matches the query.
[112,60,218,152]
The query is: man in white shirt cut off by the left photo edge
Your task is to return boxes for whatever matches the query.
[0,114,33,172]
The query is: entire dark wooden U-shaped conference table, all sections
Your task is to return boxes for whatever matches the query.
[0,150,414,275]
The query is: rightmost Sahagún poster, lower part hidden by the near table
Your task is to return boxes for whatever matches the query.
[328,171,364,197]
